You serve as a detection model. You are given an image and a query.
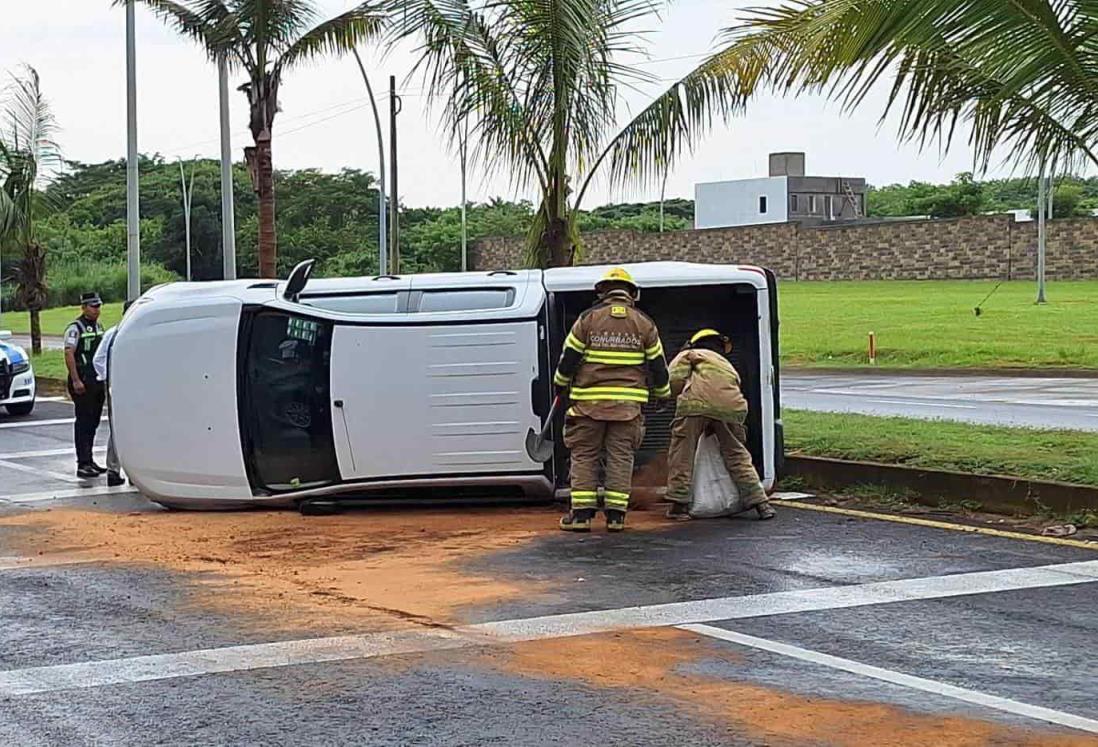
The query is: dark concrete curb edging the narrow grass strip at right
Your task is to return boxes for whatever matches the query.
[785,455,1098,514]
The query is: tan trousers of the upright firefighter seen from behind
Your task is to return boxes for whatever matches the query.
[564,415,645,511]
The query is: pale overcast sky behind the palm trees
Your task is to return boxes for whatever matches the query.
[0,0,1054,207]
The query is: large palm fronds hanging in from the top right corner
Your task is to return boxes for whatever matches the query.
[614,0,1098,186]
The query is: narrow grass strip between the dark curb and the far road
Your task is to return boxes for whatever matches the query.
[782,410,1098,486]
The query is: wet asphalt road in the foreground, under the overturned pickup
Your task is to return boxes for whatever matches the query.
[0,403,1098,747]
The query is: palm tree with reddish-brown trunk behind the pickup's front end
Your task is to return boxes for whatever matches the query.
[129,0,384,278]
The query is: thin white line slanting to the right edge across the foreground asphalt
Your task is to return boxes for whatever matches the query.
[679,625,1098,734]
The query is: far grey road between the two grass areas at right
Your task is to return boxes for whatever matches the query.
[782,371,1098,431]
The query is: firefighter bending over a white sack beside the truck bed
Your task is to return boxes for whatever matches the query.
[666,330,774,519]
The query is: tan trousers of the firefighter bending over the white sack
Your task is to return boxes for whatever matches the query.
[666,415,766,509]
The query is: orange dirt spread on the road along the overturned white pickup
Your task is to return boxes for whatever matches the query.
[0,509,663,629]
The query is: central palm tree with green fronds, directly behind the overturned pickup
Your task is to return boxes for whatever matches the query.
[390,0,731,267]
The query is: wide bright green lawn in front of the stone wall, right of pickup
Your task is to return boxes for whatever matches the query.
[778,280,1098,369]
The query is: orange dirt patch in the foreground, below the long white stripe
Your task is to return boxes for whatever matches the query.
[473,628,1096,747]
